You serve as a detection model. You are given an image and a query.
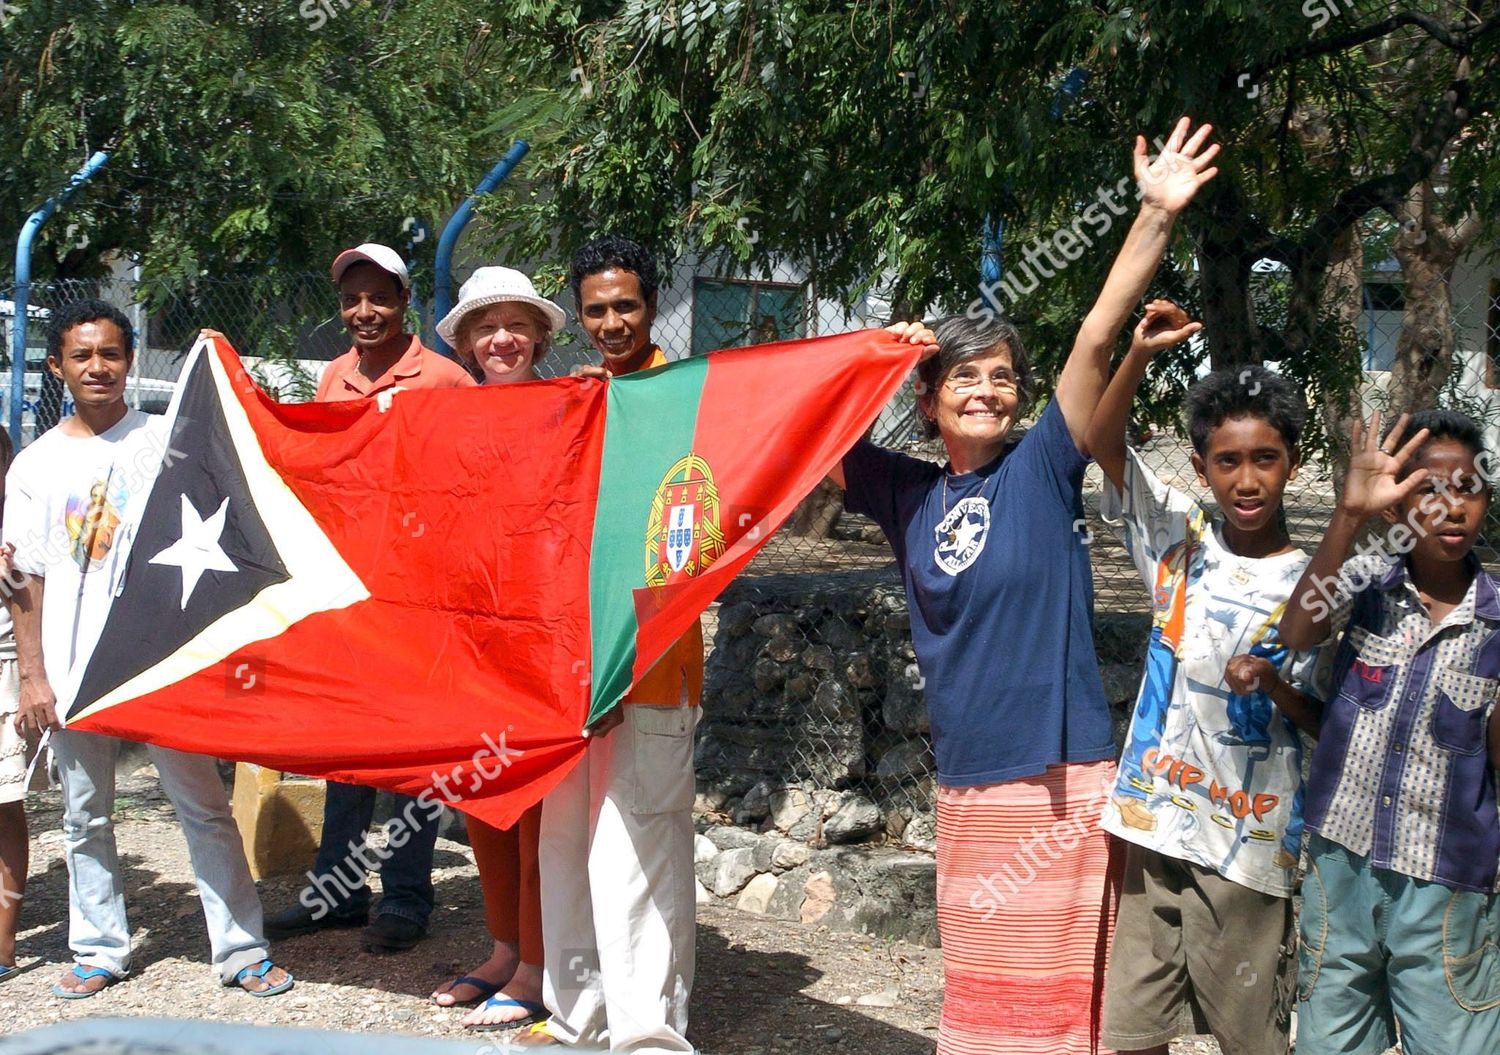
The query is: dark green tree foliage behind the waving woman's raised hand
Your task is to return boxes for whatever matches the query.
[480,0,1500,450]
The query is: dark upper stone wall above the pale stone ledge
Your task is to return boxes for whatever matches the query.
[698,567,1149,849]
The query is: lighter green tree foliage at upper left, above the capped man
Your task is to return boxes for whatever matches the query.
[0,0,516,281]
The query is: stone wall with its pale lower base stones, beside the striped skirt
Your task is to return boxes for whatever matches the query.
[696,567,1151,944]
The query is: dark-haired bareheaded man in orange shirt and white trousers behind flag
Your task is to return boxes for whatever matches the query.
[519,237,704,1052]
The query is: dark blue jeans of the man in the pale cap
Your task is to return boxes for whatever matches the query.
[312,780,443,926]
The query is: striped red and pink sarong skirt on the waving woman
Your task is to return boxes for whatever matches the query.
[938,761,1125,1055]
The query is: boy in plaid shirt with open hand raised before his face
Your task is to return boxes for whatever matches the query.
[1281,411,1500,1055]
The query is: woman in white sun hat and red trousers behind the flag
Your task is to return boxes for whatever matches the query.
[432,267,567,1032]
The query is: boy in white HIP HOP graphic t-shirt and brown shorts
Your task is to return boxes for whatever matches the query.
[1088,300,1317,1055]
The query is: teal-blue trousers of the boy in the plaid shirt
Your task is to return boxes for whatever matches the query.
[1298,834,1500,1055]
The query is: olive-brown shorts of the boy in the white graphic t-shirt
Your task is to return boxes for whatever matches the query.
[1103,843,1301,1055]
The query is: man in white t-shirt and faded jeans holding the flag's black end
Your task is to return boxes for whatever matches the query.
[3,300,293,999]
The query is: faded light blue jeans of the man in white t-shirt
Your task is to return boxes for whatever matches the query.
[53,729,267,983]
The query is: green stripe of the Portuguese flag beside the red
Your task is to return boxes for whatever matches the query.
[588,359,708,722]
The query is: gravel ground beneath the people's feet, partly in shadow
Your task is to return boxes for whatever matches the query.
[0,770,1254,1055]
